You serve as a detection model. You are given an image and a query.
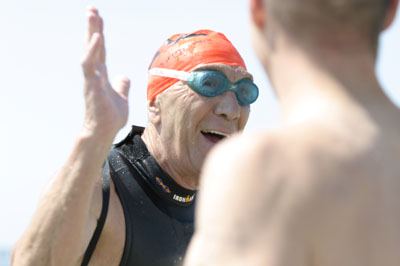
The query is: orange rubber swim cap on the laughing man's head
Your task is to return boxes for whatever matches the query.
[147,30,246,100]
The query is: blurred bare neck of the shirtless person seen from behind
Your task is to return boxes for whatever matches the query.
[268,37,390,123]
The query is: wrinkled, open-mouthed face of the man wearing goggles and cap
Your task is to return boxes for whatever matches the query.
[159,64,252,181]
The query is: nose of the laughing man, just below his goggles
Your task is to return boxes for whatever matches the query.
[215,91,241,120]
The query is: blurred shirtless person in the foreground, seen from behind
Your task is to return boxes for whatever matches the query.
[185,0,400,266]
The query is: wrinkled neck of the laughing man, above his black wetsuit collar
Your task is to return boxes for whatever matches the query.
[142,123,199,190]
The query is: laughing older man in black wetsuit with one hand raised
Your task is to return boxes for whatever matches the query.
[13,8,258,266]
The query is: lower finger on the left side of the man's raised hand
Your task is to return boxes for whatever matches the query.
[82,33,102,77]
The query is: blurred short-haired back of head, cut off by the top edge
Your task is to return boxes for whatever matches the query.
[251,0,398,53]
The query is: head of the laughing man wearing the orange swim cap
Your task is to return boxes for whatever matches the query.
[148,30,253,186]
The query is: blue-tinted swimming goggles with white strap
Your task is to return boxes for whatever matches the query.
[149,68,258,106]
